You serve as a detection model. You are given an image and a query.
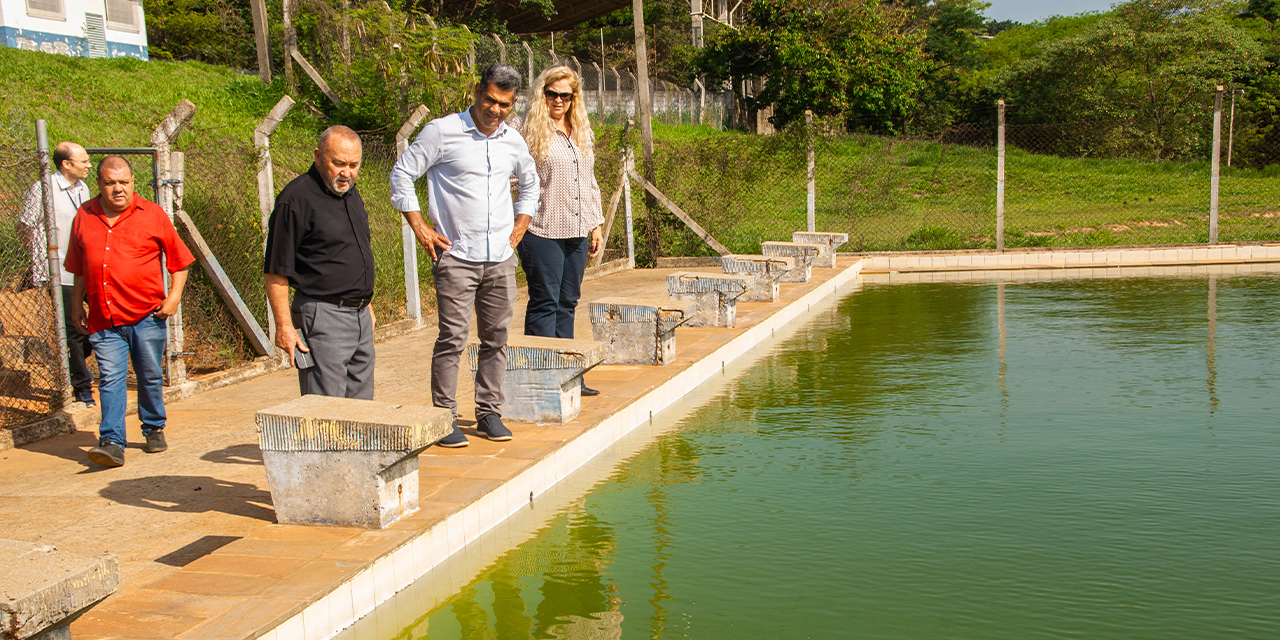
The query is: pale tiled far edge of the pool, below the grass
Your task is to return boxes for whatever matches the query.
[863,244,1280,274]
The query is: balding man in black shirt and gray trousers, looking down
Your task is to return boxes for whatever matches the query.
[264,125,374,399]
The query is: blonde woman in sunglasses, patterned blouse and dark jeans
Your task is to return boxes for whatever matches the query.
[517,67,604,396]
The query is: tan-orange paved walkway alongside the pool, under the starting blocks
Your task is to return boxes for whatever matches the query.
[0,259,855,640]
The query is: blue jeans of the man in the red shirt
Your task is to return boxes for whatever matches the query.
[88,314,169,448]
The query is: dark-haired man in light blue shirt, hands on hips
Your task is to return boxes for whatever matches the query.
[392,64,539,447]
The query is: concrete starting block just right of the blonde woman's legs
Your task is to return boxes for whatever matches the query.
[589,297,694,365]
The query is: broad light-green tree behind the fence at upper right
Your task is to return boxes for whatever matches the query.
[993,0,1266,160]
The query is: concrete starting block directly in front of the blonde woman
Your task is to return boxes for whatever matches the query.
[467,335,604,424]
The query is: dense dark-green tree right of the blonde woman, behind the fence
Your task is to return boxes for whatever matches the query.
[696,0,924,132]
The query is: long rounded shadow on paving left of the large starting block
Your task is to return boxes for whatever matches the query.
[99,476,275,522]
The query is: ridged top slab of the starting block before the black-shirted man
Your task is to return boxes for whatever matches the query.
[257,396,453,451]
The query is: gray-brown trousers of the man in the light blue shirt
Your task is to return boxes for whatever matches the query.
[431,253,516,420]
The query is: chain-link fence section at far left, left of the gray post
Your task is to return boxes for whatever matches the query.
[0,114,65,428]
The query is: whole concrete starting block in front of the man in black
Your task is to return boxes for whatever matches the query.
[257,396,453,529]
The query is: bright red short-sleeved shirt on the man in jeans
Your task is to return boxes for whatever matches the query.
[63,195,196,333]
